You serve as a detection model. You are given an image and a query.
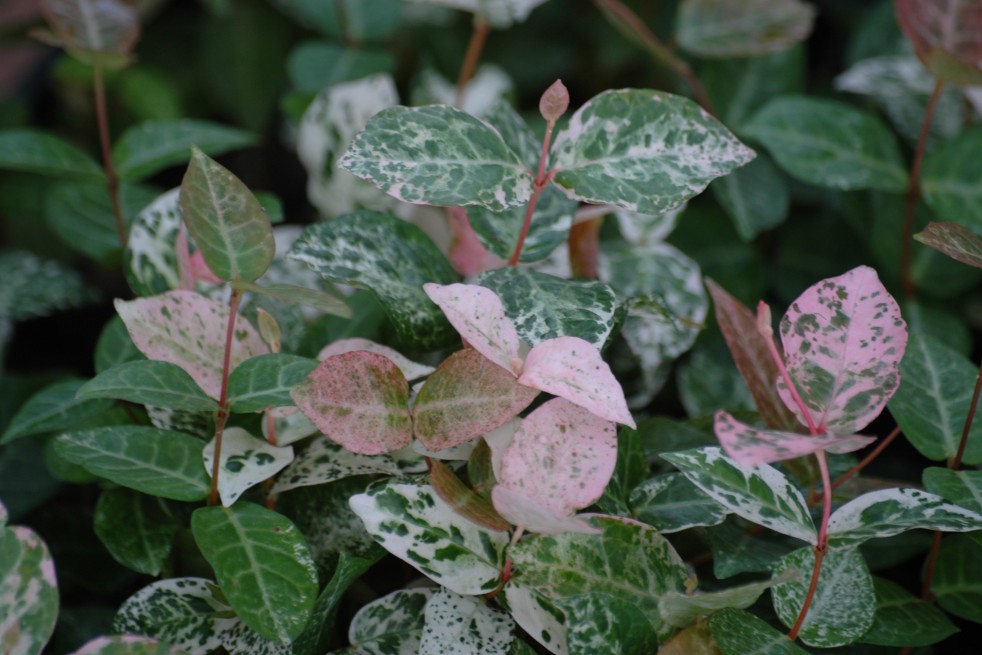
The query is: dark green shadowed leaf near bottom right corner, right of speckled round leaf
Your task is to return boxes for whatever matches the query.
[860,577,958,648]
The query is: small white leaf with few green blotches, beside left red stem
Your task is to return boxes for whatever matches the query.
[203,427,293,507]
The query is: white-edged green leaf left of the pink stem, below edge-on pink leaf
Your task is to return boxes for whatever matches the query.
[661,446,817,544]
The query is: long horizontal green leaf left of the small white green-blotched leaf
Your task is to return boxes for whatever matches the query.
[55,425,210,501]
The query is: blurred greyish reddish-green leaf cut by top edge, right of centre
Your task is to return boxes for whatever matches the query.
[675,0,815,58]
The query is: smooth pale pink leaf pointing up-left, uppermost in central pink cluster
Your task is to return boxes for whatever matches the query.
[423,282,521,374]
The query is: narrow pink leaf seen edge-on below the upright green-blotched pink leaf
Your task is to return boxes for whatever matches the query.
[714,410,876,467]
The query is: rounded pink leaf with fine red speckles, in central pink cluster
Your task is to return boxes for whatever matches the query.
[498,398,617,527]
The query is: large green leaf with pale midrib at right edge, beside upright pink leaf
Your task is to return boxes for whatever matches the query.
[888,332,982,464]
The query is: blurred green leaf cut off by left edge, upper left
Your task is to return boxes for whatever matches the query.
[0,129,105,178]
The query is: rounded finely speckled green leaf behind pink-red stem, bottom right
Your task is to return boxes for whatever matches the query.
[771,548,876,648]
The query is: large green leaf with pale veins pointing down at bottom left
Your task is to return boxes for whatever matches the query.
[191,503,318,643]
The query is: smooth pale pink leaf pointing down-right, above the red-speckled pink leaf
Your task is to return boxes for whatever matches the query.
[518,337,635,428]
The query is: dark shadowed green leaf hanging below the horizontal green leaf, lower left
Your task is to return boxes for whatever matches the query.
[92,487,182,576]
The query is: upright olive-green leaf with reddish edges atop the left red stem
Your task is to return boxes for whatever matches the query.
[181,147,276,282]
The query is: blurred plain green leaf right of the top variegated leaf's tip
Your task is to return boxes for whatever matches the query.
[743,95,907,192]
